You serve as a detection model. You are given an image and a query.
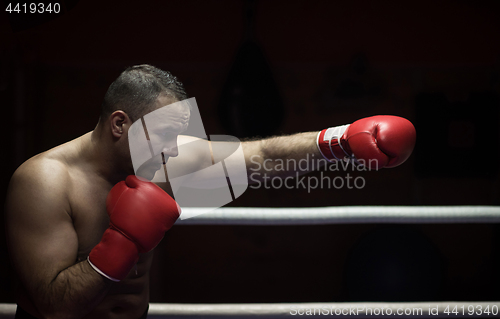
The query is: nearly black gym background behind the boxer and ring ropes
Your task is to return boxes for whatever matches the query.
[0,0,500,303]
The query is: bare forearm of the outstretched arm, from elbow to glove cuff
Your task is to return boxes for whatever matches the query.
[242,132,328,177]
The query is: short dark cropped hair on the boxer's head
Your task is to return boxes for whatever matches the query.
[101,64,188,122]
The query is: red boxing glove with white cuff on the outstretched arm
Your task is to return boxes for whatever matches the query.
[317,115,416,169]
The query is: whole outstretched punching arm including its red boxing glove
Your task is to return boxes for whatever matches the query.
[164,116,416,188]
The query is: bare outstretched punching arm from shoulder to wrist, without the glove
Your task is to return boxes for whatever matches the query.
[153,132,320,193]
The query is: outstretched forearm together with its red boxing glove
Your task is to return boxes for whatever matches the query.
[232,115,416,181]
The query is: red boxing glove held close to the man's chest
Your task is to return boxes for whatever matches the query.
[88,175,180,281]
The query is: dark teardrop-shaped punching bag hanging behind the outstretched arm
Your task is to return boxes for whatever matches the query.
[218,0,284,138]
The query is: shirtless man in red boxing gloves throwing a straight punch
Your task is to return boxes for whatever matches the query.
[6,65,415,319]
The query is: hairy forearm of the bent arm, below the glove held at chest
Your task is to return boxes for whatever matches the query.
[35,261,112,318]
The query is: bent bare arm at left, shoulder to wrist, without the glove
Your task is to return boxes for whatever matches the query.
[6,160,111,318]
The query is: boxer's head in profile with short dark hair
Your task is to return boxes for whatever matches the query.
[96,64,189,179]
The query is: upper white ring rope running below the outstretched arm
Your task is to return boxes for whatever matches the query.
[176,206,500,226]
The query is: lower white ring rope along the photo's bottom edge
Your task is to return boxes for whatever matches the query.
[0,301,500,319]
